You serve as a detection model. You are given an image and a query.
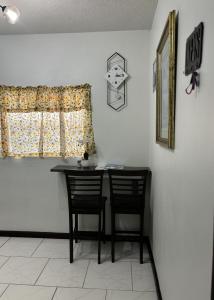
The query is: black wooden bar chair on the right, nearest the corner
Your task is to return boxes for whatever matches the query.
[108,169,149,263]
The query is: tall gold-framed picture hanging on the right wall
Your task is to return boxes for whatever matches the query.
[156,10,177,149]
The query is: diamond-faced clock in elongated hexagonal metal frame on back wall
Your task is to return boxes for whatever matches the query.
[105,52,128,111]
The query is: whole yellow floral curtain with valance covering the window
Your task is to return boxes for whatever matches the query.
[0,84,95,157]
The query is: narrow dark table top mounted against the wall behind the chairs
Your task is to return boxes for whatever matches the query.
[50,165,151,173]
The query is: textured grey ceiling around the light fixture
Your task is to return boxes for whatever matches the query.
[0,0,158,34]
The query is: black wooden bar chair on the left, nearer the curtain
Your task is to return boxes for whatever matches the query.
[65,170,106,264]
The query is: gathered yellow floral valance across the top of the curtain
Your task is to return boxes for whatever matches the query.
[0,84,91,112]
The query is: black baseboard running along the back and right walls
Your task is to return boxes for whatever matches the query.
[0,230,163,300]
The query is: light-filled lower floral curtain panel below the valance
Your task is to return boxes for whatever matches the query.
[3,110,90,157]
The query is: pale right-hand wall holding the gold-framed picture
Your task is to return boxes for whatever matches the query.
[150,0,214,300]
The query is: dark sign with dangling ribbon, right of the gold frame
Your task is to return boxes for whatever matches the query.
[185,22,204,95]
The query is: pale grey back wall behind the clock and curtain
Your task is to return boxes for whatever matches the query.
[0,31,149,232]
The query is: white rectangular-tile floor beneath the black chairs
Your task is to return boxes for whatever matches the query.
[0,237,157,300]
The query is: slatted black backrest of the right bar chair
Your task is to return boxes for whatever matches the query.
[108,169,149,208]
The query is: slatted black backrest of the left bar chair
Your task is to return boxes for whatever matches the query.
[65,170,103,200]
